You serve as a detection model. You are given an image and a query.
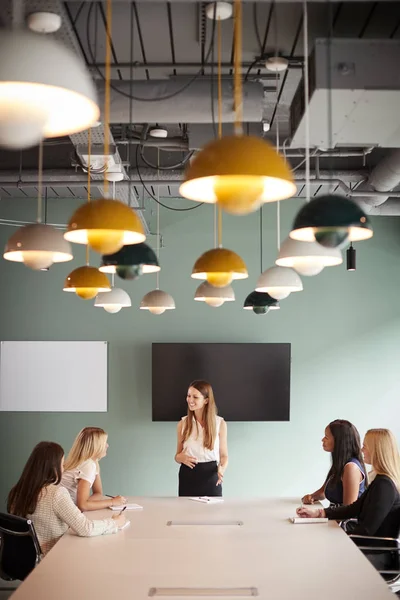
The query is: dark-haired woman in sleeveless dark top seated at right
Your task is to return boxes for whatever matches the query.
[302,419,367,505]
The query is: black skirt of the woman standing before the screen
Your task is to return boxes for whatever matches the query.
[178,461,222,496]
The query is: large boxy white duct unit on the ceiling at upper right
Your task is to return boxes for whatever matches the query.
[290,38,400,148]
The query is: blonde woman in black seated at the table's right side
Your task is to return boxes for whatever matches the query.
[297,429,400,538]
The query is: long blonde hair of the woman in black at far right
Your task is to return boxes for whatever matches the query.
[364,429,400,489]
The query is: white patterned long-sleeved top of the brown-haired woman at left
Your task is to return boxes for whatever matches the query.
[28,485,118,554]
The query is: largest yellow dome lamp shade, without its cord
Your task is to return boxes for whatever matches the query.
[179,136,297,215]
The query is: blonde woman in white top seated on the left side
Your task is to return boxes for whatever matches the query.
[61,427,126,511]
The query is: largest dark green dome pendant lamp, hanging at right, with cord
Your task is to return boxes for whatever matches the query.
[290,2,373,248]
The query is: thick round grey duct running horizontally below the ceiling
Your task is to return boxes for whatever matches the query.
[97,79,264,124]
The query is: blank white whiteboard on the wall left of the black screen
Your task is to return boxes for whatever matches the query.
[0,342,108,412]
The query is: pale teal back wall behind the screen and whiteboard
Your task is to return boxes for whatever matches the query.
[0,198,400,505]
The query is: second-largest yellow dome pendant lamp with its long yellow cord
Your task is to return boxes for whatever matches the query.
[64,0,146,254]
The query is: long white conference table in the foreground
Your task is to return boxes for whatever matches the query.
[12,498,393,600]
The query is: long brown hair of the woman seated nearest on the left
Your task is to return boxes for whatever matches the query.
[7,442,64,518]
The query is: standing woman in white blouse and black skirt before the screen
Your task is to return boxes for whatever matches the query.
[175,380,228,496]
